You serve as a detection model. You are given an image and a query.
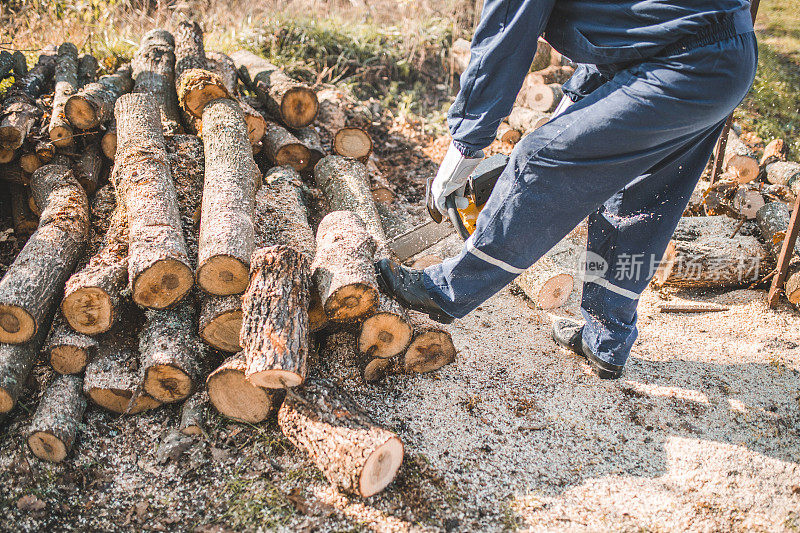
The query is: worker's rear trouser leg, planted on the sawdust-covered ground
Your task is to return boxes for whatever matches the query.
[581,124,722,367]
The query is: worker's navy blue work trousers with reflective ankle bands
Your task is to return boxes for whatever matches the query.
[424,32,757,365]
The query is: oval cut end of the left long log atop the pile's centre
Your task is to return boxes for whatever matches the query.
[133,259,194,309]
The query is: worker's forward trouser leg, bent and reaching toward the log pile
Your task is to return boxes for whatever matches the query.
[424,34,756,317]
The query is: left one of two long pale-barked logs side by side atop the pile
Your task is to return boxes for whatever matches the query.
[111,93,194,309]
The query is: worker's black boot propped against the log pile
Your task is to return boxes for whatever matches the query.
[375,259,454,324]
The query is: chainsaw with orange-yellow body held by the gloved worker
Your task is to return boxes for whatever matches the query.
[389,154,508,261]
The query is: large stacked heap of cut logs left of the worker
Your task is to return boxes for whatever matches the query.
[0,22,455,496]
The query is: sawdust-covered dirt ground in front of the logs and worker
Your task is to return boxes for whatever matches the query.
[0,118,800,532]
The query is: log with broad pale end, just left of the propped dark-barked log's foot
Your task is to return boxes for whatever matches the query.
[206,353,285,424]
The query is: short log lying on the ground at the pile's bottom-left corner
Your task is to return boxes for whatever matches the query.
[28,376,86,463]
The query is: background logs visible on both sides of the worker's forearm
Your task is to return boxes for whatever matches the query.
[451,38,575,144]
